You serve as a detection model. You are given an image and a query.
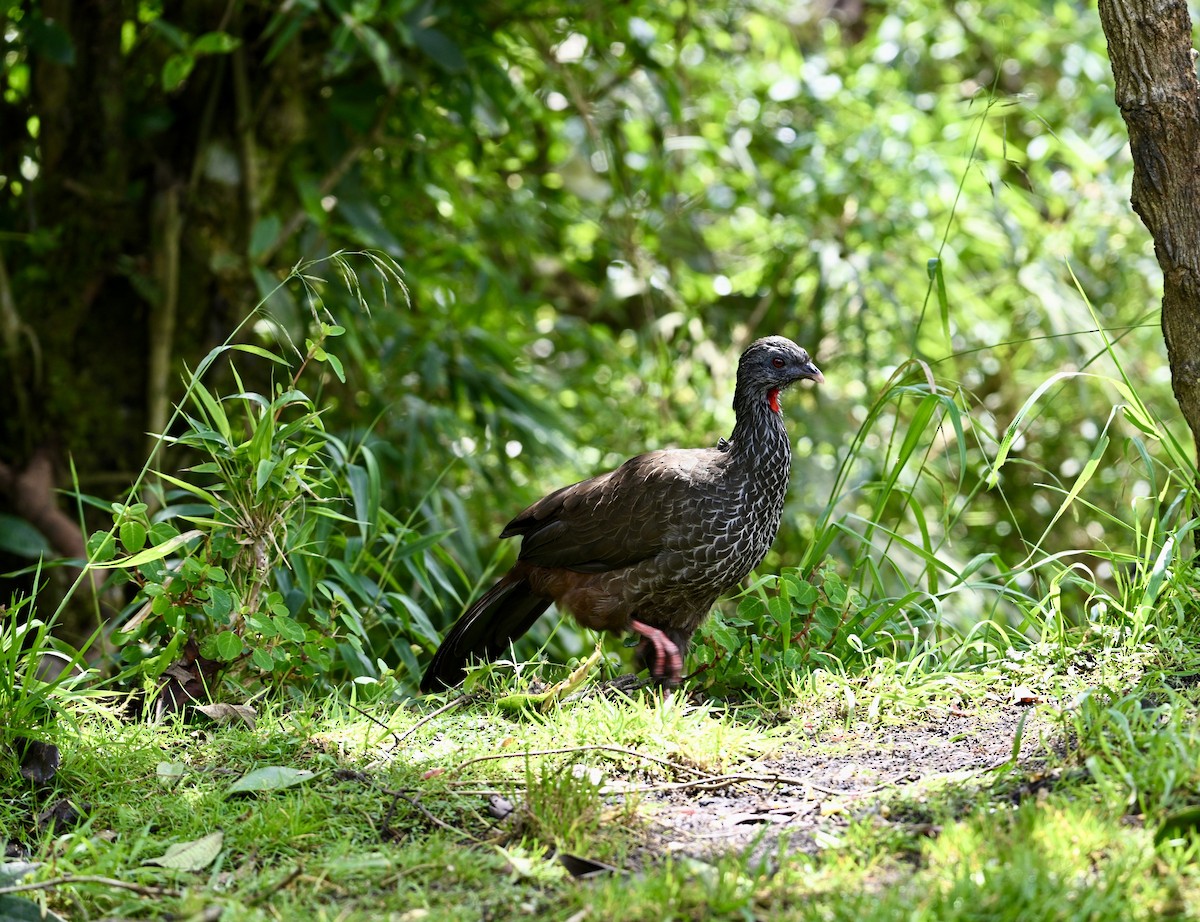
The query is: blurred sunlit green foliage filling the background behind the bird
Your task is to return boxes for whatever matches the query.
[0,0,1175,691]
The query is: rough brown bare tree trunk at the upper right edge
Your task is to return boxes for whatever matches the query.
[1099,0,1200,457]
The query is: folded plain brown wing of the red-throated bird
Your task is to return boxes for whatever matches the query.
[500,449,726,573]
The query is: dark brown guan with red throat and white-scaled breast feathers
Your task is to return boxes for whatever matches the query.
[421,336,824,692]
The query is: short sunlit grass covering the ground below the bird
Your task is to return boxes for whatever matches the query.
[7,631,1200,920]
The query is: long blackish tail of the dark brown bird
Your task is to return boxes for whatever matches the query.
[421,573,552,693]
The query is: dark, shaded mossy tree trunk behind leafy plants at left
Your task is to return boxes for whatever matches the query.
[0,0,314,640]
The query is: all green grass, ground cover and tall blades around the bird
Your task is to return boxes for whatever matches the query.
[0,241,1200,922]
